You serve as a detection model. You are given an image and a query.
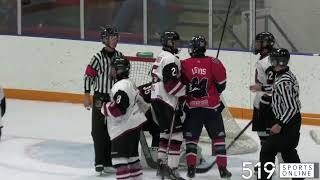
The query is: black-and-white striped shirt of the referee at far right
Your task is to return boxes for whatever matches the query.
[272,67,301,125]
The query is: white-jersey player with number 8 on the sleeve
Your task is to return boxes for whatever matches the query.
[101,57,149,180]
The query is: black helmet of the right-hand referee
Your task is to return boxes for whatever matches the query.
[269,48,290,66]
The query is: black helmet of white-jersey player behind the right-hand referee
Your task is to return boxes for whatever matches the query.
[254,32,275,54]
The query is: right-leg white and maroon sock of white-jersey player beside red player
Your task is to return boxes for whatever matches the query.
[168,132,183,168]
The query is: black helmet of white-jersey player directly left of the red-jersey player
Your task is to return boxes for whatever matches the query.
[160,31,180,54]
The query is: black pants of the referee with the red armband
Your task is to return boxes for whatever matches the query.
[91,92,112,167]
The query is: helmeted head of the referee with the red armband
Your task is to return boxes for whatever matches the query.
[100,25,119,49]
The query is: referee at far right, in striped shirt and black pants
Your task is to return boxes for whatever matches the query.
[260,48,301,179]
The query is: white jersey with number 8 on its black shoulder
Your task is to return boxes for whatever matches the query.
[101,79,148,140]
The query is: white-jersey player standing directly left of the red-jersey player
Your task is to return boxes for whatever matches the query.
[151,31,186,179]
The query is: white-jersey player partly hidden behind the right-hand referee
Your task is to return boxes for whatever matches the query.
[250,32,283,171]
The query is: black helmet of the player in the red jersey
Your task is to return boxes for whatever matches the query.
[188,35,207,56]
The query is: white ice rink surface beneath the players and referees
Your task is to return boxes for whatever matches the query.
[0,99,320,180]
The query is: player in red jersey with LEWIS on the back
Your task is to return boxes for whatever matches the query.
[181,35,232,178]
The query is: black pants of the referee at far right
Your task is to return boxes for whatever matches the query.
[260,113,301,180]
